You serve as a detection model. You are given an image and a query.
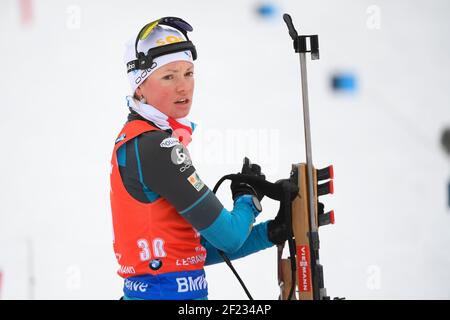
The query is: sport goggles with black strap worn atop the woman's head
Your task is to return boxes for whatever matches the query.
[127,17,197,72]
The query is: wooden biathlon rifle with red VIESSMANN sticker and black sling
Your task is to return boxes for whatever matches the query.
[213,14,340,300]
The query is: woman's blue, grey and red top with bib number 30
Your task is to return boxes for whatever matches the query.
[110,114,273,299]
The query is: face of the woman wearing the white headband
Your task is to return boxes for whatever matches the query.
[136,61,194,119]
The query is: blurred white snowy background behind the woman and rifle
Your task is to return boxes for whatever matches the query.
[0,0,450,299]
